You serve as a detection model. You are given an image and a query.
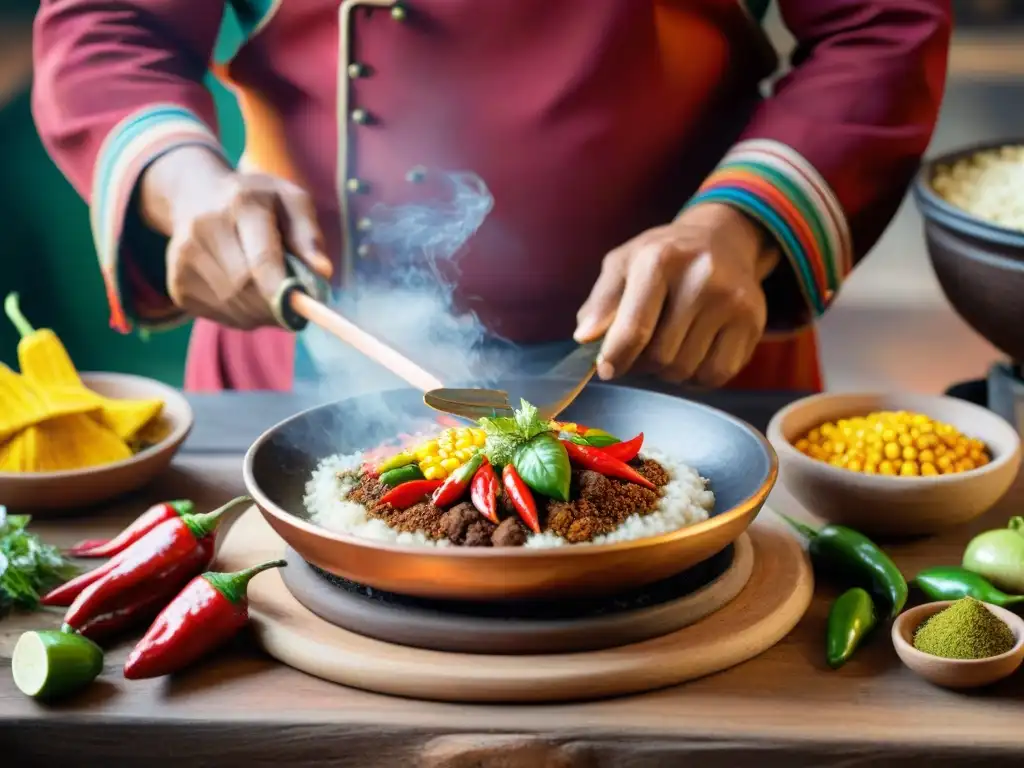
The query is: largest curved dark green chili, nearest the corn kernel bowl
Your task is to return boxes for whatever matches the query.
[779,515,909,618]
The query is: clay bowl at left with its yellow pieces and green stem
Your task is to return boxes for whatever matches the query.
[0,294,193,511]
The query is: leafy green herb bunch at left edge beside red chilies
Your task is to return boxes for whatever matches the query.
[0,505,78,616]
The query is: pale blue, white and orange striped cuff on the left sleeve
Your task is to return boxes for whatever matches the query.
[90,104,223,333]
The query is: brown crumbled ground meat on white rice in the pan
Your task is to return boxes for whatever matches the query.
[348,459,669,547]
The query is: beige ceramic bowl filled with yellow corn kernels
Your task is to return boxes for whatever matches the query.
[767,393,1021,537]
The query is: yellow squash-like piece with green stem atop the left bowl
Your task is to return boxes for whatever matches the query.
[0,293,164,441]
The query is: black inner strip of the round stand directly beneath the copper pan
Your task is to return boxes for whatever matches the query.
[309,545,735,622]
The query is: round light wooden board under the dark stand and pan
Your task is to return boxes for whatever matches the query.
[217,509,814,702]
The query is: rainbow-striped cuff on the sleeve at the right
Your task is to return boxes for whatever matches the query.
[688,139,853,316]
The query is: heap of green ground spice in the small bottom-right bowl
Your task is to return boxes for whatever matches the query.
[913,597,1017,658]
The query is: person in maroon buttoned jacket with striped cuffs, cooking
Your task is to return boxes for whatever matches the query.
[33,0,951,390]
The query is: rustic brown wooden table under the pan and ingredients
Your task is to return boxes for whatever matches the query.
[0,396,1024,768]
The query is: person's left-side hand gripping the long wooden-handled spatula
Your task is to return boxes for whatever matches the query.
[140,146,332,330]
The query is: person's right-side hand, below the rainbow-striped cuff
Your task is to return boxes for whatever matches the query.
[575,203,778,387]
